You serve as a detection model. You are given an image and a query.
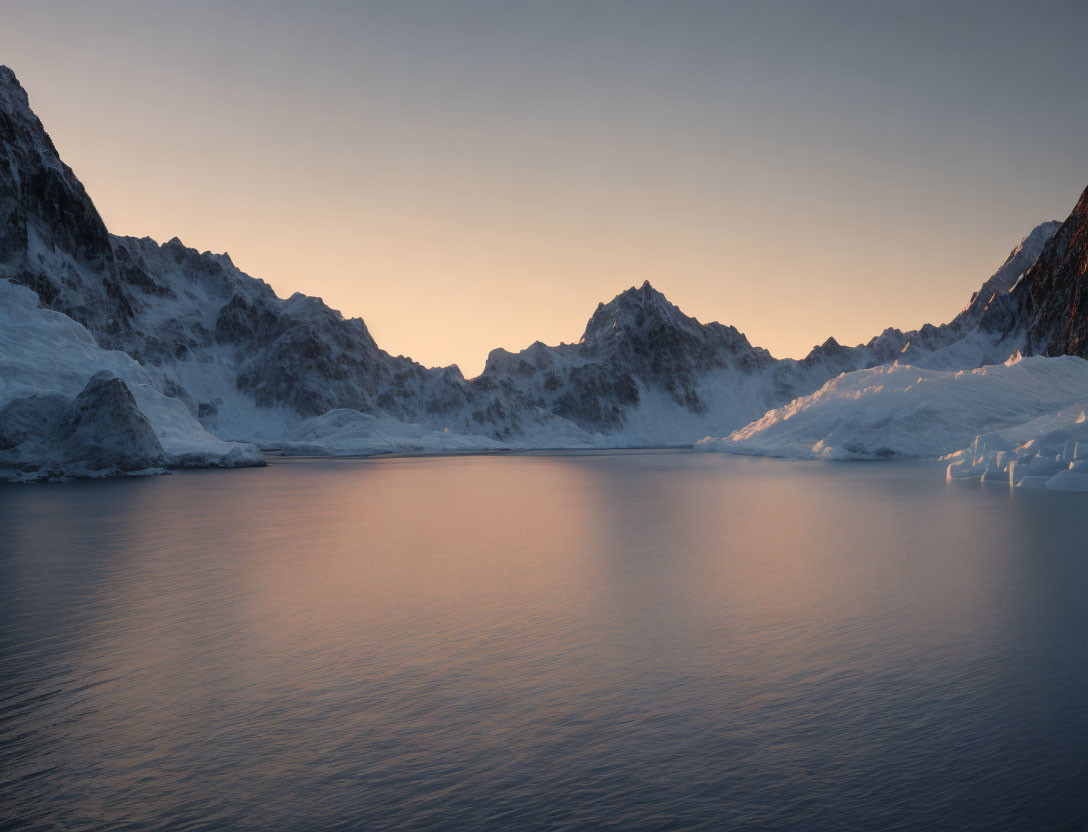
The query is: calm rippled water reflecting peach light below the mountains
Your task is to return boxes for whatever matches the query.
[0,452,1088,830]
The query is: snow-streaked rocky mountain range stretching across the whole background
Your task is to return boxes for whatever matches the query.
[0,67,1088,479]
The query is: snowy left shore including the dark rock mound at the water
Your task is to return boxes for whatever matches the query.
[0,281,264,481]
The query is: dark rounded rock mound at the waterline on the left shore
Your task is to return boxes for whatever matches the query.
[0,371,165,481]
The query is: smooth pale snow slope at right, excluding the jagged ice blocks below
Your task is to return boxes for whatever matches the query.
[695,356,1088,467]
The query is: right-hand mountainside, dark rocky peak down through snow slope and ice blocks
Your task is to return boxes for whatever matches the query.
[697,203,1088,480]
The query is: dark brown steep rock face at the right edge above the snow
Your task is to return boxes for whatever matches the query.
[1013,184,1088,358]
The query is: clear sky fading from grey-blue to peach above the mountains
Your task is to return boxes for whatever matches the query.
[0,0,1088,375]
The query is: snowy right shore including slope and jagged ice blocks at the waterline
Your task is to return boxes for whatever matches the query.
[695,355,1088,490]
